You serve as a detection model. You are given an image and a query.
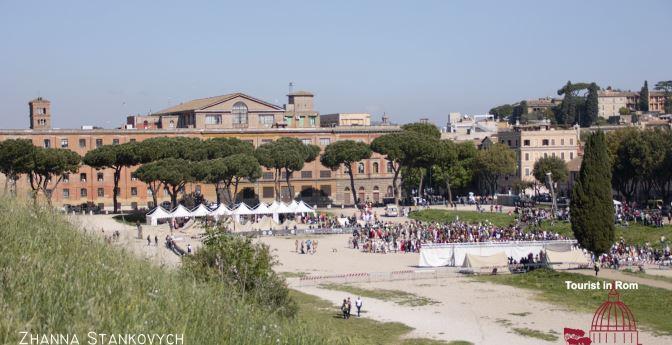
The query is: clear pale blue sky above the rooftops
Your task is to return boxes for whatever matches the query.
[0,0,672,128]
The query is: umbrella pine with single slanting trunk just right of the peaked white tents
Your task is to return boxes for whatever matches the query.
[320,140,371,203]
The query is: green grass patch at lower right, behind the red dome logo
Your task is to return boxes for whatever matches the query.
[473,270,672,335]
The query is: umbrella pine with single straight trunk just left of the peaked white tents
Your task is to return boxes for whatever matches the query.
[82,142,141,213]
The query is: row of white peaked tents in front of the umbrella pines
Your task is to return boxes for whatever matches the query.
[147,200,315,225]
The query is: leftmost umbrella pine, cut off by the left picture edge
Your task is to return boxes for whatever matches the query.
[0,139,35,195]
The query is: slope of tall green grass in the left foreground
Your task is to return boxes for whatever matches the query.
[0,199,336,344]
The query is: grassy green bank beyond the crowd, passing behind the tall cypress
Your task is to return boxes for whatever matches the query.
[410,210,672,248]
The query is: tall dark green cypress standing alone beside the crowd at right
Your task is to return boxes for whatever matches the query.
[570,131,615,255]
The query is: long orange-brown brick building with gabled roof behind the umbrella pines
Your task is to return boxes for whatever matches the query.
[0,92,399,209]
